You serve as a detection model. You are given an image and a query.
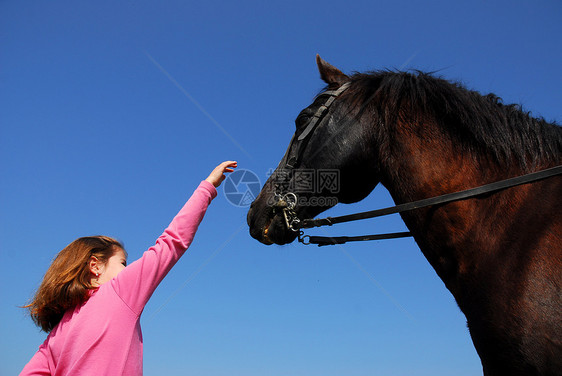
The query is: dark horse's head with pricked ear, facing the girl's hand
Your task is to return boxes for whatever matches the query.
[247,56,378,244]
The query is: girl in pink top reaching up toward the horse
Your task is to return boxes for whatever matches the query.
[20,161,237,376]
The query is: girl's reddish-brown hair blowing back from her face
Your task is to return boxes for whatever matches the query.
[23,236,124,333]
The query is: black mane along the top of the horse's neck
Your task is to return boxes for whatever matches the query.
[349,70,562,170]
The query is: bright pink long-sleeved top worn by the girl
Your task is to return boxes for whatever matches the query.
[20,181,217,376]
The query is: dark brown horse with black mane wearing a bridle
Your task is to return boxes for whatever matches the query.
[247,55,562,376]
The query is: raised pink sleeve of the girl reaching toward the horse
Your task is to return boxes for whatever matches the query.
[110,181,217,315]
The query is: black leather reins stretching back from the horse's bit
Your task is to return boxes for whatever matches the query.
[283,165,562,247]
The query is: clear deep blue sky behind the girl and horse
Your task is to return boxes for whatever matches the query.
[0,0,562,376]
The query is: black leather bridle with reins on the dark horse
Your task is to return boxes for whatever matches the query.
[274,82,562,247]
